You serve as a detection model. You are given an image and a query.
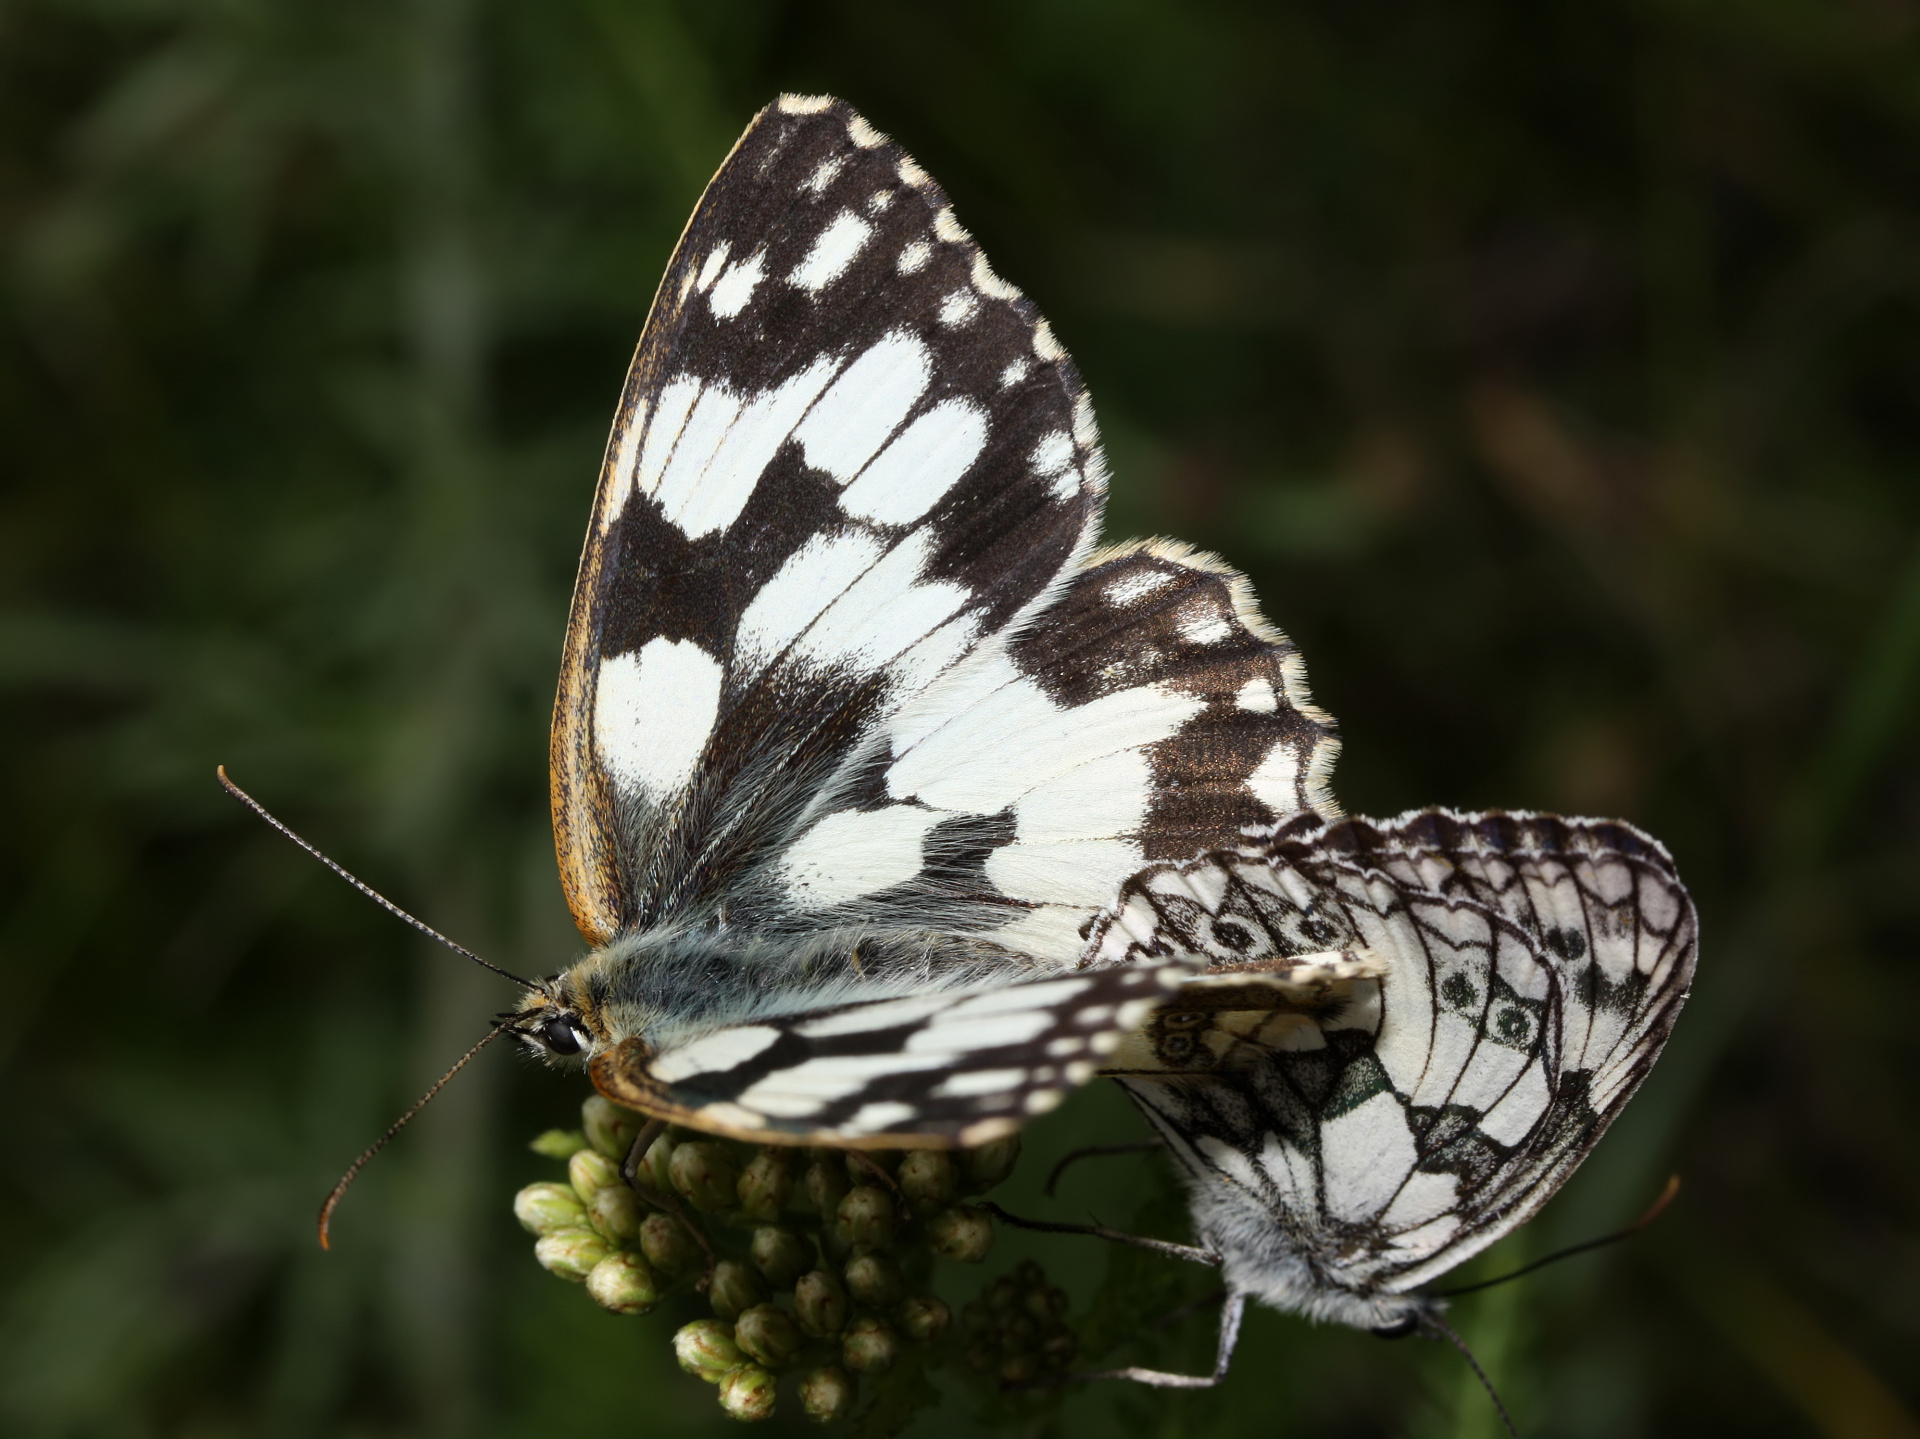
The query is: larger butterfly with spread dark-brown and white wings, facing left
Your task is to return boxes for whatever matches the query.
[511,96,1336,1145]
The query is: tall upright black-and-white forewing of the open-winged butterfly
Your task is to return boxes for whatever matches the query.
[553,96,1104,945]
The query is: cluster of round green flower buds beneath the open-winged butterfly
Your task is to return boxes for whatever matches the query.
[515,1095,1021,1422]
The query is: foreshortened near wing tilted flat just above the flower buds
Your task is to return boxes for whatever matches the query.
[591,964,1187,1149]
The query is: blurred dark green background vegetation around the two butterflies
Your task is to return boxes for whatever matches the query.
[0,0,1920,1439]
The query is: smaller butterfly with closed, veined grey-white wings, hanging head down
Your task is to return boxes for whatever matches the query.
[1087,811,1697,1385]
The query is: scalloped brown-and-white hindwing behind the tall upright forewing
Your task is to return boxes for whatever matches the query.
[833,540,1338,964]
